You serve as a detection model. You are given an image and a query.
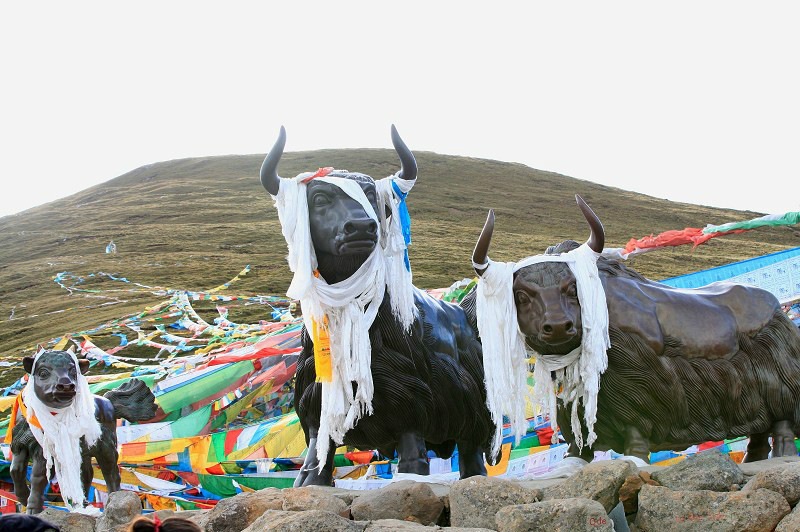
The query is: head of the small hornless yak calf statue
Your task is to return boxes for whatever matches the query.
[22,351,89,408]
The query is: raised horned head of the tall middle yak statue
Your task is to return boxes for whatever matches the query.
[261,126,417,284]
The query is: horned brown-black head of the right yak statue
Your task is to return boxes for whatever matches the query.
[472,196,605,355]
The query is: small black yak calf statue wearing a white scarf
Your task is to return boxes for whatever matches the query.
[11,351,157,513]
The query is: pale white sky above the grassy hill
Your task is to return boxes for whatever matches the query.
[0,1,800,218]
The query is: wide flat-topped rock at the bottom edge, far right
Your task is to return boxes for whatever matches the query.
[636,484,789,532]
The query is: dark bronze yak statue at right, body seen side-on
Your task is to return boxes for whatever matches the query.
[464,197,800,461]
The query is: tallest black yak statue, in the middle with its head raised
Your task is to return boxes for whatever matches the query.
[261,126,494,486]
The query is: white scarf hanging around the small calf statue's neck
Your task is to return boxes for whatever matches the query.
[22,350,101,514]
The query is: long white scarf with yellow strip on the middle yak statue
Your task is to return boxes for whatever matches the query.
[273,168,417,469]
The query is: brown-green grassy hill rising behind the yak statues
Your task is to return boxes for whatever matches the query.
[0,149,800,362]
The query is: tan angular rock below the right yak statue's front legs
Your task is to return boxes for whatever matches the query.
[544,460,637,514]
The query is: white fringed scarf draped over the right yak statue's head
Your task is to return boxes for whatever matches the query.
[474,244,611,456]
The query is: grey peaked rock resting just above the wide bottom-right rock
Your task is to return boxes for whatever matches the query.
[652,449,745,491]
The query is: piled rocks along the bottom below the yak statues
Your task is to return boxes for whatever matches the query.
[28,451,800,532]
